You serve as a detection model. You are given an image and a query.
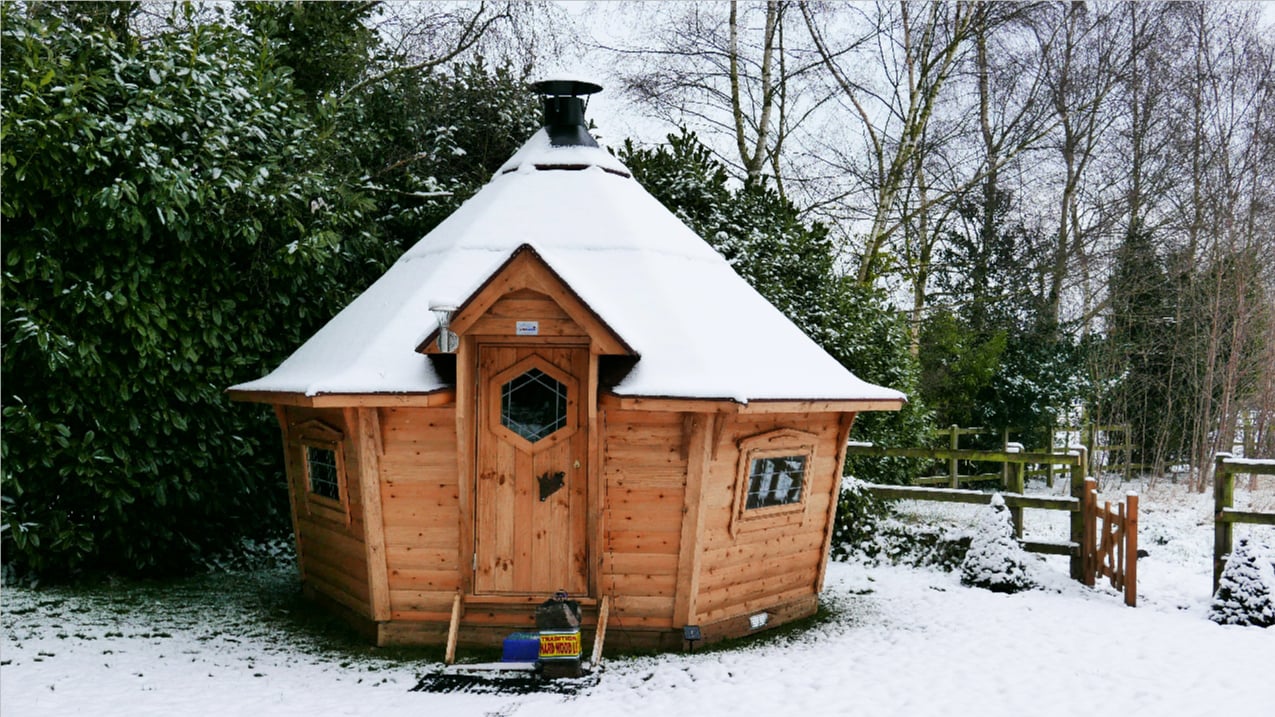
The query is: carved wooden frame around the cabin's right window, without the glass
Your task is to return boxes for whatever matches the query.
[731,429,819,537]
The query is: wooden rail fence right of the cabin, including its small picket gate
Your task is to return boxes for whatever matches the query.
[847,443,1137,606]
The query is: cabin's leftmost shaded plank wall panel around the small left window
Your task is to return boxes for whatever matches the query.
[286,406,370,615]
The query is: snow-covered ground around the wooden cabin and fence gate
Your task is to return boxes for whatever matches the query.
[0,474,1275,717]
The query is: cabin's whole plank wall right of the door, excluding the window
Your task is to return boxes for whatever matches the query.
[602,410,842,647]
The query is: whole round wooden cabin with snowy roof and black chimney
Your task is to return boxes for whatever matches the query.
[230,80,904,649]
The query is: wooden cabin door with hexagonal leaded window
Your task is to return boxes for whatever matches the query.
[473,344,589,597]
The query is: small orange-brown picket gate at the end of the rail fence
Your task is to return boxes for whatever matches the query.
[1080,478,1137,607]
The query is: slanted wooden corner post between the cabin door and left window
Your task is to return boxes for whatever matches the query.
[349,407,390,623]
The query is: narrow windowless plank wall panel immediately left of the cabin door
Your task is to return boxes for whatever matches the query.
[380,406,462,624]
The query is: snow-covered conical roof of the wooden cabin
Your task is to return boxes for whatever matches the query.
[231,129,904,403]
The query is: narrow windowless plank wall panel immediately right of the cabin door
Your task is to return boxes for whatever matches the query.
[601,410,687,630]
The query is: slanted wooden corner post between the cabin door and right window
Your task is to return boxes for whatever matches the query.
[673,413,720,628]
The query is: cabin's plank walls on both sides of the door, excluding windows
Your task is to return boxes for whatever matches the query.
[284,406,842,649]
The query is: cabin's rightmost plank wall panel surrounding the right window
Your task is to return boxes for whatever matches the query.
[692,413,842,625]
